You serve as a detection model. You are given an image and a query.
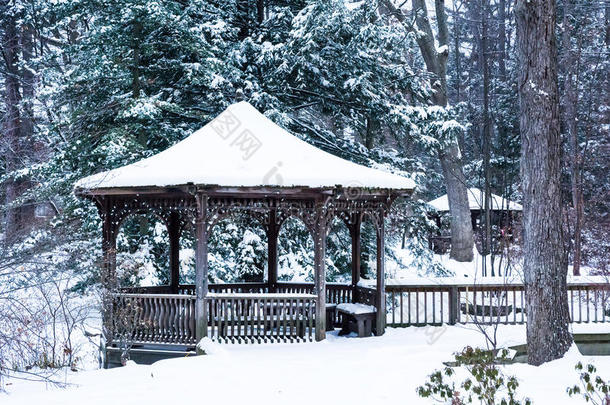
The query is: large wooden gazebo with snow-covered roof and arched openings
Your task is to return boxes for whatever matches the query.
[75,102,414,360]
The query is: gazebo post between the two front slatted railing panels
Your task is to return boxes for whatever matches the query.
[195,194,208,343]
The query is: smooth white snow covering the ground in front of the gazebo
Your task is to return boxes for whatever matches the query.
[0,325,610,405]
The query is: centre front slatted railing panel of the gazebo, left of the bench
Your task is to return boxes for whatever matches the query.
[207,293,316,343]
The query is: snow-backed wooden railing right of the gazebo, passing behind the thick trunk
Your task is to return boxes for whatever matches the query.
[386,283,610,327]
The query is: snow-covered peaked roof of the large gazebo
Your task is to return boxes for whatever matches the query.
[75,102,415,195]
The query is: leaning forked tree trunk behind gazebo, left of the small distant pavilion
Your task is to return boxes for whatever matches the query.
[381,0,474,262]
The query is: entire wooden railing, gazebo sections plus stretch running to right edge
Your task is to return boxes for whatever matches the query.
[109,283,610,346]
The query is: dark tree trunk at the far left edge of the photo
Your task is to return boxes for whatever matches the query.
[2,7,21,242]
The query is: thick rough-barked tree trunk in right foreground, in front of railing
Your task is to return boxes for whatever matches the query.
[515,0,572,365]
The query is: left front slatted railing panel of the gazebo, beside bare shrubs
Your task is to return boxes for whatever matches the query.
[109,293,195,345]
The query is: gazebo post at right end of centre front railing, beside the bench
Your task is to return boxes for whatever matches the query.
[313,206,326,342]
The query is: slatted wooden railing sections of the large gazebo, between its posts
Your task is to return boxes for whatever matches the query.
[109,283,353,346]
